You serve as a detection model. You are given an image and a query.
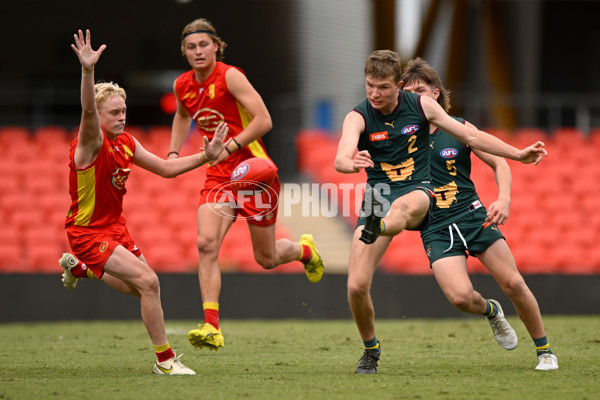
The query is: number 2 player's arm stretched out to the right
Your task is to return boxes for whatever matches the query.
[420,96,548,165]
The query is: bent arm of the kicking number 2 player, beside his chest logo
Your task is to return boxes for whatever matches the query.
[335,111,375,174]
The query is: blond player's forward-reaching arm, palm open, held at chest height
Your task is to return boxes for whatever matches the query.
[133,123,229,178]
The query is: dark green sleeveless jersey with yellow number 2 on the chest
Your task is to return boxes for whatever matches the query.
[354,92,430,186]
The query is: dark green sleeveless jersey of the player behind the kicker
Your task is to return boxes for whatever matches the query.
[423,117,483,233]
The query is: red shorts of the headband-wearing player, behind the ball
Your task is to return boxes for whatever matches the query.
[199,175,281,226]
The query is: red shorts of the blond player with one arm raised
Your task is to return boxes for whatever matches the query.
[67,222,142,279]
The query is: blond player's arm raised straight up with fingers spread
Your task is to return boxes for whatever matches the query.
[71,29,106,168]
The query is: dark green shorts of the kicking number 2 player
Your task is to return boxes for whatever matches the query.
[355,182,435,231]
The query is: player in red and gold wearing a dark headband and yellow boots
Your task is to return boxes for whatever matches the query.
[168,19,323,350]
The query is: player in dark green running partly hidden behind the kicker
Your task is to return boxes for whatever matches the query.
[402,57,558,371]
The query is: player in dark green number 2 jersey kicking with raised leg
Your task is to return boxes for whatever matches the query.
[335,50,546,374]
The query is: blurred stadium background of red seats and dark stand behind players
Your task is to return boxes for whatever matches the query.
[0,0,600,320]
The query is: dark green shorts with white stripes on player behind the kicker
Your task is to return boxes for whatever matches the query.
[421,207,504,265]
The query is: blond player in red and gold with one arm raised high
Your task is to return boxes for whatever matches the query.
[59,30,228,375]
